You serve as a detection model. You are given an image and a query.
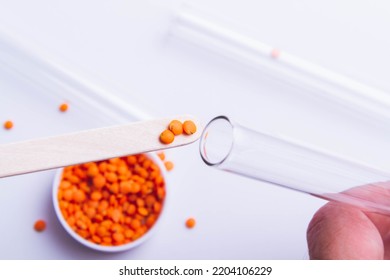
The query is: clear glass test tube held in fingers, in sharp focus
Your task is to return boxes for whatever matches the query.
[200,116,390,215]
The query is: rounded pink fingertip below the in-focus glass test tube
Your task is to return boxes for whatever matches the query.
[306,202,384,260]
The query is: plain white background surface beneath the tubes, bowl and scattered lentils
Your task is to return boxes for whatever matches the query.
[0,0,390,259]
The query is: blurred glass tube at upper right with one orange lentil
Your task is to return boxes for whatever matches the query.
[172,6,390,125]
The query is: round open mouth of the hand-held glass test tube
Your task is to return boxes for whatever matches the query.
[200,116,234,166]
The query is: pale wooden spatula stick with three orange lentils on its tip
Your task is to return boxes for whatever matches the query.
[0,115,202,178]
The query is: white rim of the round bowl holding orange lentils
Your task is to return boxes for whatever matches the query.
[52,153,169,252]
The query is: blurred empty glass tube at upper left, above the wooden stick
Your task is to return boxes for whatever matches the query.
[0,23,151,123]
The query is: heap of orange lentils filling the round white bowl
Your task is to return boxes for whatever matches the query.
[57,155,165,246]
